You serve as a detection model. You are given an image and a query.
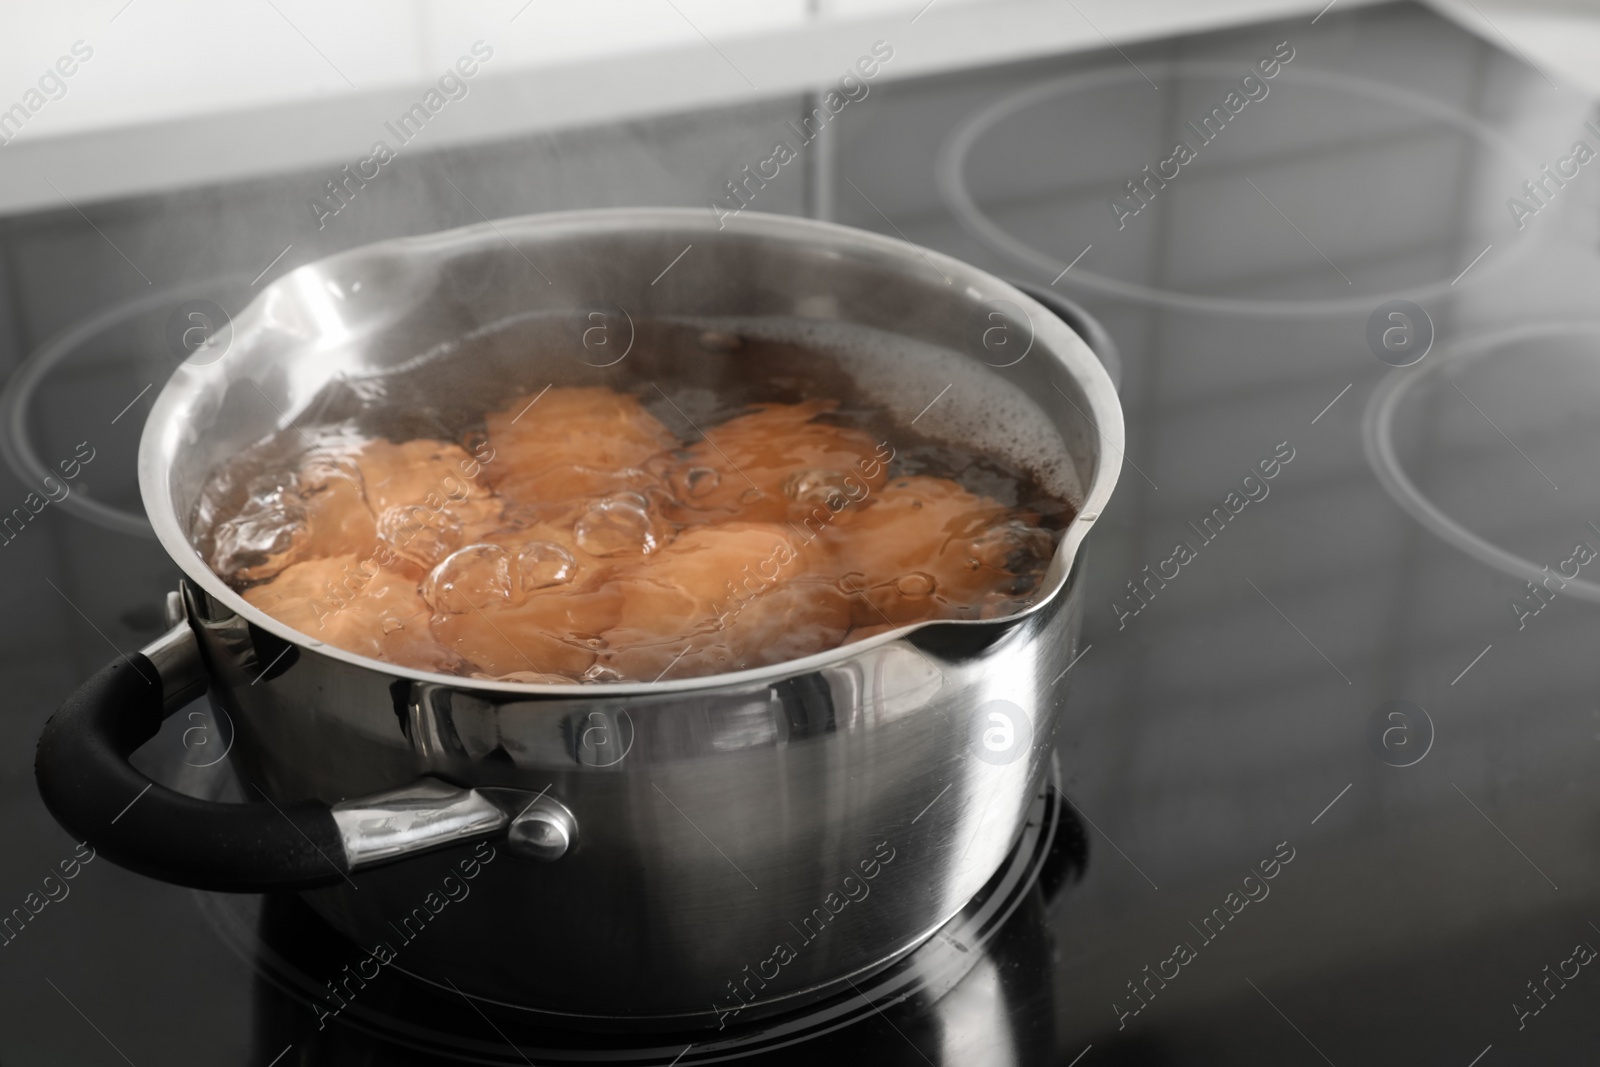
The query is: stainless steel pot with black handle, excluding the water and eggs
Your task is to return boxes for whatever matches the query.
[37,210,1122,1025]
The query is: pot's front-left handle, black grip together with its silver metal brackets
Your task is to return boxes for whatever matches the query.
[34,619,578,893]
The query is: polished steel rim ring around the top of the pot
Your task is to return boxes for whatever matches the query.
[138,208,1123,699]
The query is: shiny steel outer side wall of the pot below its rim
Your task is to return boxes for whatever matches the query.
[200,556,1078,1025]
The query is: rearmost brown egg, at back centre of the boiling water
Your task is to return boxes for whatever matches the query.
[483,386,678,504]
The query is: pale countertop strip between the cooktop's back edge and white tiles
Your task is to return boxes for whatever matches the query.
[0,0,1379,214]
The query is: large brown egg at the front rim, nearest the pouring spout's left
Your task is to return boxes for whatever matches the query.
[598,523,850,681]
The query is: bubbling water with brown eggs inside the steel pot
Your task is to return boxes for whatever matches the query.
[192,317,1082,683]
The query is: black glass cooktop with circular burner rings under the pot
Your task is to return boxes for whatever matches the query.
[0,5,1600,1067]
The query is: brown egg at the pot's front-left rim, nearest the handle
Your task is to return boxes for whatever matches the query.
[245,553,461,670]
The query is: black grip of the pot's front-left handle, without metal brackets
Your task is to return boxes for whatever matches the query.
[34,653,350,893]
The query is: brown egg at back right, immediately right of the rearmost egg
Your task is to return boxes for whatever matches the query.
[666,400,893,523]
